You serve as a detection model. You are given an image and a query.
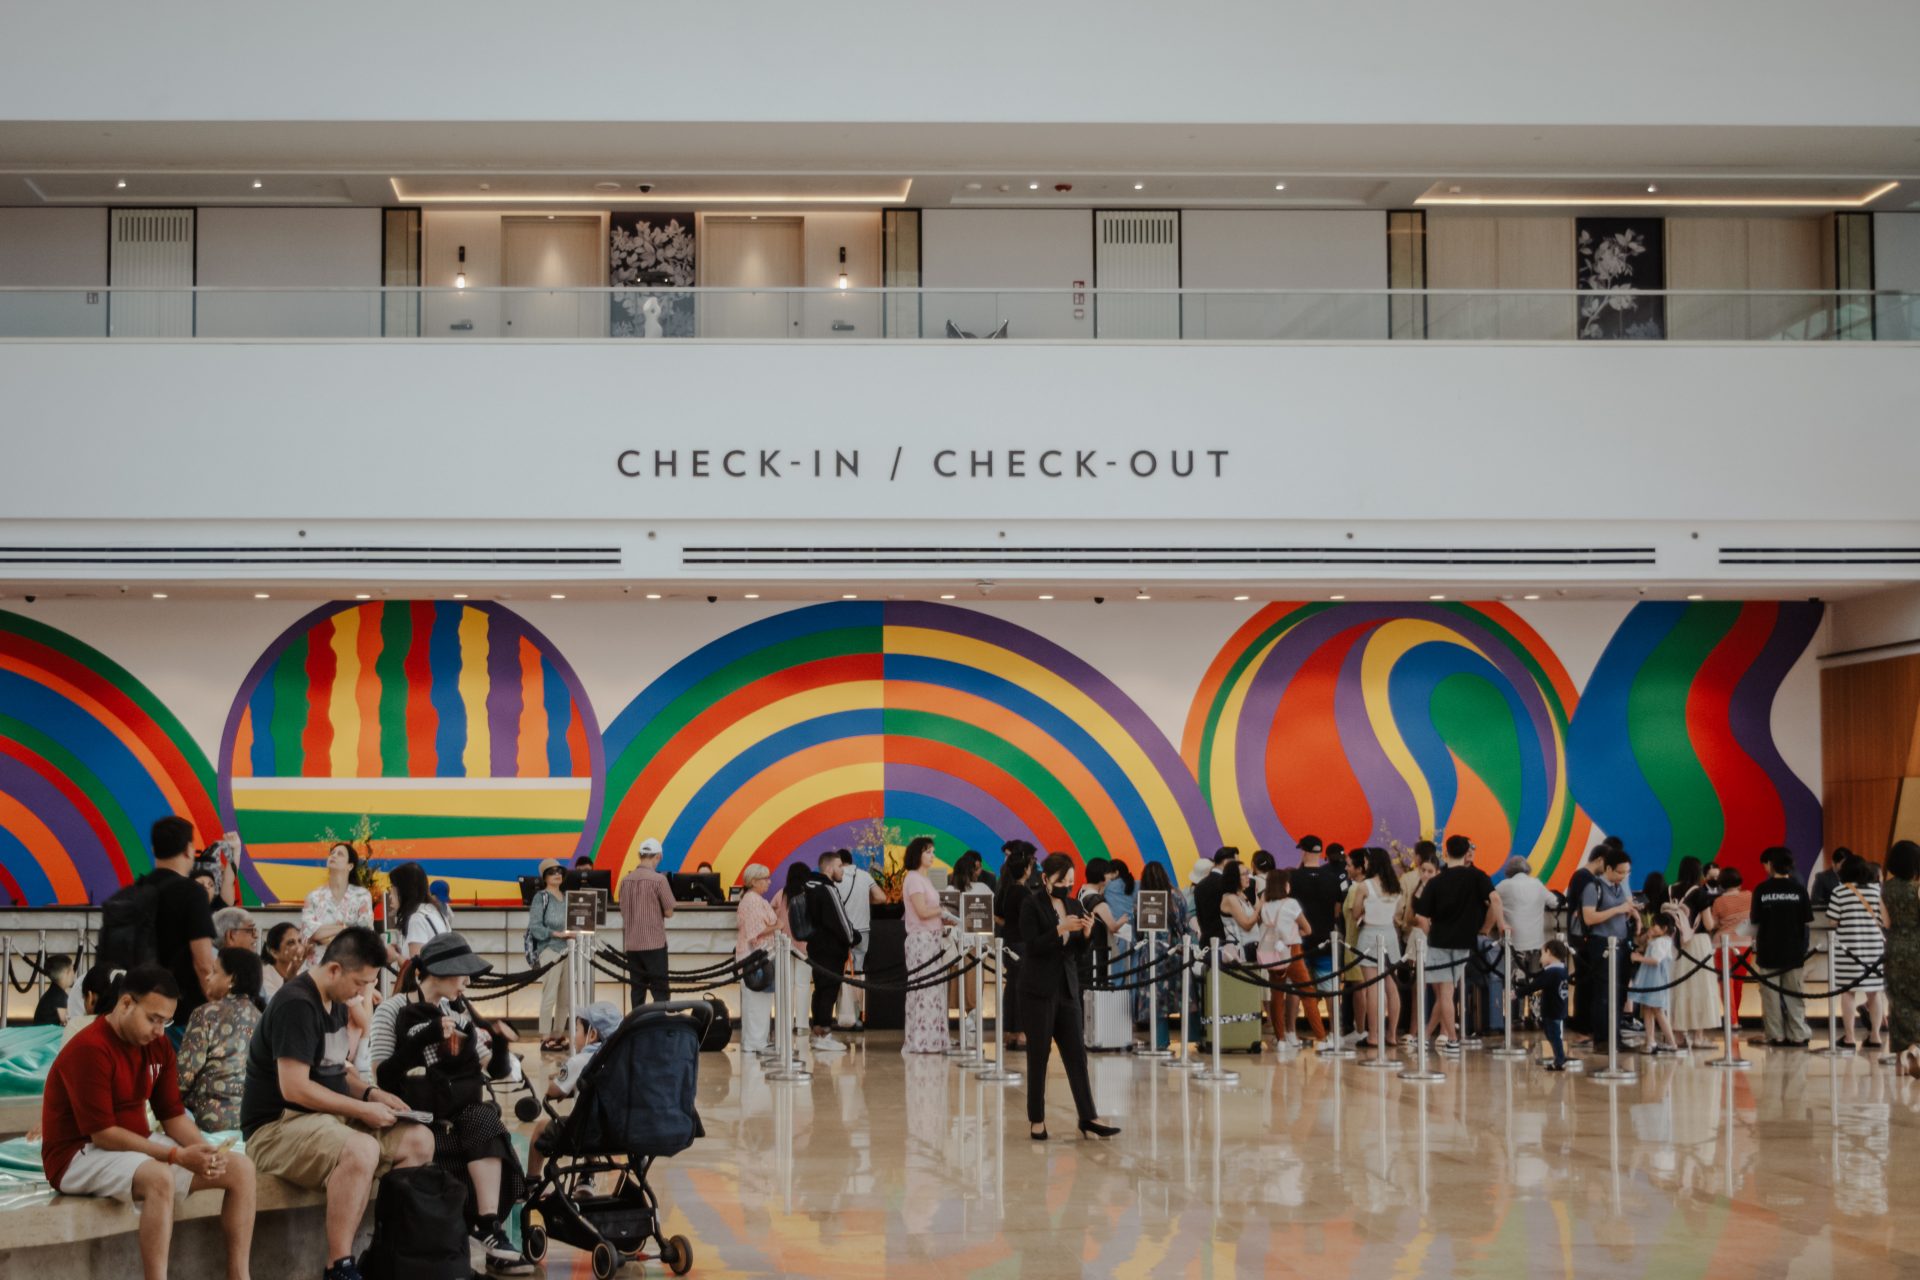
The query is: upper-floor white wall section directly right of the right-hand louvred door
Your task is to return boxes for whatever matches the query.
[1181,209,1388,340]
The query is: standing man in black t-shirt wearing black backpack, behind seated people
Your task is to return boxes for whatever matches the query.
[100,816,217,1050]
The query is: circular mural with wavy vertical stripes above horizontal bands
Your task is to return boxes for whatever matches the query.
[219,601,601,902]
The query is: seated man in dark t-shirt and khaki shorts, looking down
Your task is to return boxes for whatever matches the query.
[240,925,434,1280]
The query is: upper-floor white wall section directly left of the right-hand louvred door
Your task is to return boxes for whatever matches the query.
[920,209,1092,338]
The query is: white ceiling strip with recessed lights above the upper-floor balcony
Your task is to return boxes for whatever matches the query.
[0,121,1920,209]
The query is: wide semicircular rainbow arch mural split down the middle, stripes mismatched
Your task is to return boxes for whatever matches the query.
[599,603,1215,879]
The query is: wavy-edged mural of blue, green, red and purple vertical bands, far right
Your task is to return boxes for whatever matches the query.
[1569,601,1826,885]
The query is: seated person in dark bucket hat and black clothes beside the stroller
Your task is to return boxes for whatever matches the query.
[371,933,534,1274]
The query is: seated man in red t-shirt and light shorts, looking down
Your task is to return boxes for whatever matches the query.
[40,965,253,1280]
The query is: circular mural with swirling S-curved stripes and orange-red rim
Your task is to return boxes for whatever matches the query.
[1181,603,1590,883]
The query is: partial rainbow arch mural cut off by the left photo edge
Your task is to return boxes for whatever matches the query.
[0,610,238,906]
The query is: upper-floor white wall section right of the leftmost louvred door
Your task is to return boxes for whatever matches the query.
[194,209,382,338]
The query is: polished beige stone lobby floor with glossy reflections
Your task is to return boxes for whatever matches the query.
[518,1032,1920,1280]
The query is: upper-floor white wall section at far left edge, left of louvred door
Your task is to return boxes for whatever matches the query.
[0,209,108,338]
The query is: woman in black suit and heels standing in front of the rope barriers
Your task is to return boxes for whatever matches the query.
[1020,854,1119,1142]
